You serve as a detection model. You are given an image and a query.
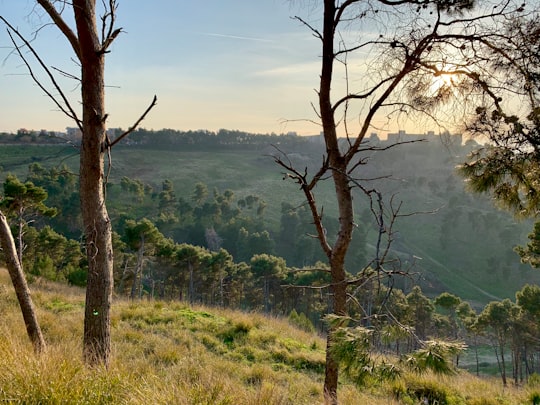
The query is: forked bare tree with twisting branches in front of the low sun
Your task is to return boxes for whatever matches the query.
[276,0,526,404]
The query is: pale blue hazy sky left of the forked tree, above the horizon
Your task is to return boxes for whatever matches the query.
[0,0,326,134]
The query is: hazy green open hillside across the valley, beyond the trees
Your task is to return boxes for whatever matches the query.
[0,142,540,308]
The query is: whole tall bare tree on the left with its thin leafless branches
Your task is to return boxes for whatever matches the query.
[0,0,156,366]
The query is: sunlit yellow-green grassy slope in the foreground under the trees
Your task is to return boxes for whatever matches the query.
[0,270,540,405]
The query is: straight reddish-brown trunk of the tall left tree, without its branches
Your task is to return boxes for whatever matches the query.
[73,0,113,366]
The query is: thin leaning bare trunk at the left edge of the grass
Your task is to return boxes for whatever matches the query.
[0,212,45,353]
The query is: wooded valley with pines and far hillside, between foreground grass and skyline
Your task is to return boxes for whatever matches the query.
[0,130,540,382]
